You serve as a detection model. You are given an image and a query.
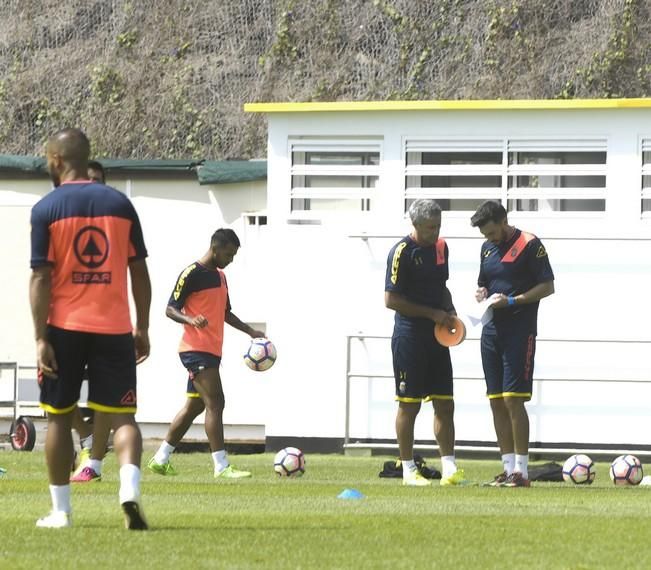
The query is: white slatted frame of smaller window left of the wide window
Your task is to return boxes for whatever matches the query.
[287,136,384,220]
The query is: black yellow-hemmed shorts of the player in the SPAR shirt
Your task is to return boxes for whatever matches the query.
[38,325,137,414]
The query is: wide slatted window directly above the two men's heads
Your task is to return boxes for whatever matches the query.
[405,139,608,213]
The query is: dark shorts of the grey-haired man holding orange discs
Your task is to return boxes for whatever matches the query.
[391,334,453,402]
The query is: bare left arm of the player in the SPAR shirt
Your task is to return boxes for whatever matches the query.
[29,265,58,378]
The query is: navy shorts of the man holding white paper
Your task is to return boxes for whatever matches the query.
[481,331,536,400]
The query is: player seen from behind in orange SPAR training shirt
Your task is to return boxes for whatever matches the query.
[30,128,151,530]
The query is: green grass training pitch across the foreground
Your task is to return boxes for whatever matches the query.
[0,451,651,570]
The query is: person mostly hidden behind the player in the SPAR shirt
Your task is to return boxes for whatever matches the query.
[70,160,111,483]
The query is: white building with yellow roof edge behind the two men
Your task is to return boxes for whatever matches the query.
[245,99,651,449]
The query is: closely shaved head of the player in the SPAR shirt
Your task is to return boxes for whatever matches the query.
[46,128,90,186]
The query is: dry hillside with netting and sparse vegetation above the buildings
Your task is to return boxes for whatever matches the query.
[0,0,651,159]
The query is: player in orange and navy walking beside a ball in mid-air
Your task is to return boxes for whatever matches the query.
[148,229,265,479]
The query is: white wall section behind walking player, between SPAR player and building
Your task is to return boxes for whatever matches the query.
[126,181,266,424]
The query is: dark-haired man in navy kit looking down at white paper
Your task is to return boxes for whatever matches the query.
[470,200,554,487]
